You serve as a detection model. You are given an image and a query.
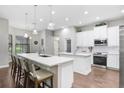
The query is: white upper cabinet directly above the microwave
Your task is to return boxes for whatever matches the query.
[94,25,107,39]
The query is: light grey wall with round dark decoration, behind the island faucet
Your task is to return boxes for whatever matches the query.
[31,30,54,55]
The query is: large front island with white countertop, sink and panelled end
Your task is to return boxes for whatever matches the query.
[18,53,73,88]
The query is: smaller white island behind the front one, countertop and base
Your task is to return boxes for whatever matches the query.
[60,52,93,75]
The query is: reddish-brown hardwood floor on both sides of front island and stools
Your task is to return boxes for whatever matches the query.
[0,67,119,88]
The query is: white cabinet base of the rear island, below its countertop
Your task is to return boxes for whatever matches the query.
[60,54,91,75]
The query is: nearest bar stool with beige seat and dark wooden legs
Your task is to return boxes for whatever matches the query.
[29,64,53,88]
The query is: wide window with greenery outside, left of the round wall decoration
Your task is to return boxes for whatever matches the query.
[15,36,30,54]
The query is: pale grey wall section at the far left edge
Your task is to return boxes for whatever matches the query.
[0,18,8,66]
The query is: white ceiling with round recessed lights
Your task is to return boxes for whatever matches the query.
[0,5,124,30]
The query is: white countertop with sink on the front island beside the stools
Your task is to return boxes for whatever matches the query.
[18,53,73,67]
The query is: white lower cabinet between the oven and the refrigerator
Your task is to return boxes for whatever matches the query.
[107,54,119,69]
